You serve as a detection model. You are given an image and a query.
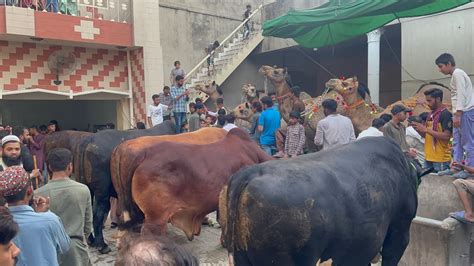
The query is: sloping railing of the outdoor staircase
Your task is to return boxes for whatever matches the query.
[185,4,264,85]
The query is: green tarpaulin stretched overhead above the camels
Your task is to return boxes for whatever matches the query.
[263,0,471,48]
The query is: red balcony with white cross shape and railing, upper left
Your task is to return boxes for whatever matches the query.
[0,0,133,48]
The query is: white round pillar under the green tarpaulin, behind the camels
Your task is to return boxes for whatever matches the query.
[367,28,383,104]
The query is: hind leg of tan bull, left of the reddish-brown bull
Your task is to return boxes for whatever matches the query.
[110,144,146,228]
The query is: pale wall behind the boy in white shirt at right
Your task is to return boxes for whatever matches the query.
[402,4,474,98]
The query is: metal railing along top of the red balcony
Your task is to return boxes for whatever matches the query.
[0,0,132,23]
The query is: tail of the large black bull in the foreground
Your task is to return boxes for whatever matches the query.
[221,167,259,253]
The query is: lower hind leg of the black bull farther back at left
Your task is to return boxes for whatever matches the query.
[93,196,111,254]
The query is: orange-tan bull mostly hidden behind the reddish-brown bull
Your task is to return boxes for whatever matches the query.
[110,128,227,228]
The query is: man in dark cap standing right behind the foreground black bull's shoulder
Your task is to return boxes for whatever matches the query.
[383,104,416,158]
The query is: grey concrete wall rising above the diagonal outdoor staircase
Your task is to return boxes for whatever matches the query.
[157,0,262,85]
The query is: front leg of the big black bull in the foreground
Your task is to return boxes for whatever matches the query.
[382,224,410,266]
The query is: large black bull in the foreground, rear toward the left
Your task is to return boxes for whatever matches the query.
[219,137,418,266]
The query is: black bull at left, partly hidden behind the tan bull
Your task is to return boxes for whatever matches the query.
[75,121,175,253]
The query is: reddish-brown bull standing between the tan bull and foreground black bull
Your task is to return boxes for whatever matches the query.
[117,128,271,240]
